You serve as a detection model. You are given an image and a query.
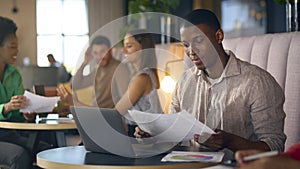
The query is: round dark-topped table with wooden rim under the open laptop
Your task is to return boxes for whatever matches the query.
[37,146,216,169]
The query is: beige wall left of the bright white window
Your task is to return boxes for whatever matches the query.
[0,0,36,65]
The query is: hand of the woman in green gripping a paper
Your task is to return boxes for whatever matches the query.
[4,95,29,114]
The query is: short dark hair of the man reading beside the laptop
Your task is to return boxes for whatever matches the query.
[183,9,221,31]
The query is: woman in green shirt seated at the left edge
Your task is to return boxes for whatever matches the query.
[0,16,35,169]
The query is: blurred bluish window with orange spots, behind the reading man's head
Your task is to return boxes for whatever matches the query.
[221,0,267,38]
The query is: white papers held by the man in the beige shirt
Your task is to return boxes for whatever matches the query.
[125,110,215,143]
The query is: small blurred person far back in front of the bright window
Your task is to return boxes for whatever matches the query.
[47,53,72,83]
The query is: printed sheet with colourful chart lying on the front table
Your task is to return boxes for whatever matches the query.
[161,151,224,163]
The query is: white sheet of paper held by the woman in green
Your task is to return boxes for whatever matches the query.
[20,91,59,113]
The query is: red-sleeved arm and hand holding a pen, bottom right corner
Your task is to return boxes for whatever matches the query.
[235,142,300,169]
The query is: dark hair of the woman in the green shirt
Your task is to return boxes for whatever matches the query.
[0,16,18,46]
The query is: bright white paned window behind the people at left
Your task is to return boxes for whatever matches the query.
[36,0,89,71]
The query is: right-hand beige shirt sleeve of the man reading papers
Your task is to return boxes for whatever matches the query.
[250,72,286,152]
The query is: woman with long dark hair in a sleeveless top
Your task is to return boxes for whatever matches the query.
[116,30,163,137]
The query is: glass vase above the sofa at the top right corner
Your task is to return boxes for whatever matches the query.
[286,0,299,32]
